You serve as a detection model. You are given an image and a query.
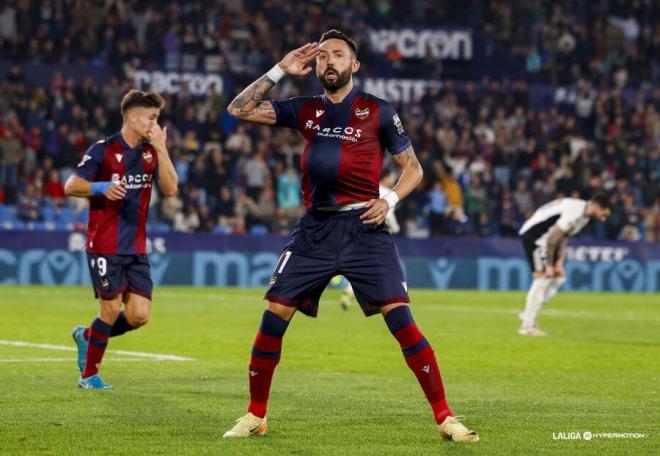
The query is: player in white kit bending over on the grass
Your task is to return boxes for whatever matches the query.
[518,193,611,336]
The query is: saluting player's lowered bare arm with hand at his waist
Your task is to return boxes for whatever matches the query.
[360,146,423,225]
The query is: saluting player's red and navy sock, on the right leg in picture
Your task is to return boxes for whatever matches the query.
[384,305,454,424]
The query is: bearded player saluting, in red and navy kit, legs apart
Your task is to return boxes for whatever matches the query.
[224,30,479,441]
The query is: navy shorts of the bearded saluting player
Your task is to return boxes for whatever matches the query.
[264,209,410,317]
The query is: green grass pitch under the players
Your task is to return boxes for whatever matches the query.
[0,287,660,455]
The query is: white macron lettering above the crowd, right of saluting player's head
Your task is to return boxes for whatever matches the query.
[369,28,474,61]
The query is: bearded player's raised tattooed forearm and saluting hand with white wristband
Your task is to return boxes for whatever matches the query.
[227,43,321,125]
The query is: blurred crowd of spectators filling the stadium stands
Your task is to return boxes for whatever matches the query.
[0,0,660,242]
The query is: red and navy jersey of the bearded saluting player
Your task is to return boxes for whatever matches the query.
[271,88,410,209]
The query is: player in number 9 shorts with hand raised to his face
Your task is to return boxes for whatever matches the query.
[65,90,178,389]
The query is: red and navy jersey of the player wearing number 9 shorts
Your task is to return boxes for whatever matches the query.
[75,133,158,255]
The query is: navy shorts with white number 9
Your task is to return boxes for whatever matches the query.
[87,252,153,300]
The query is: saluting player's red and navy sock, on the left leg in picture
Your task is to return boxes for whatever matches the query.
[248,310,289,418]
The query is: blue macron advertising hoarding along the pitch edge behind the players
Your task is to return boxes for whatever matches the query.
[0,231,660,293]
